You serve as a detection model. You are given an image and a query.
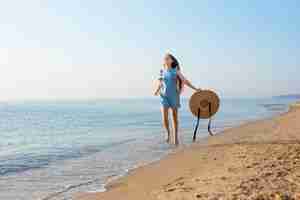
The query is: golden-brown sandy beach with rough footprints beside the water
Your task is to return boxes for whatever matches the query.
[75,104,300,200]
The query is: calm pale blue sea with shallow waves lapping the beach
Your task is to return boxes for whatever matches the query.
[0,98,294,200]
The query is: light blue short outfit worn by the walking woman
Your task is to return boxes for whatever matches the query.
[160,68,180,108]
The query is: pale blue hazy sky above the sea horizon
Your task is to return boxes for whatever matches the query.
[0,0,300,100]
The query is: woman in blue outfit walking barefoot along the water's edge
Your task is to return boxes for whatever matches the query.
[154,54,200,145]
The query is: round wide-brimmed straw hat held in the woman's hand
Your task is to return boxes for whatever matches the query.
[190,90,220,119]
